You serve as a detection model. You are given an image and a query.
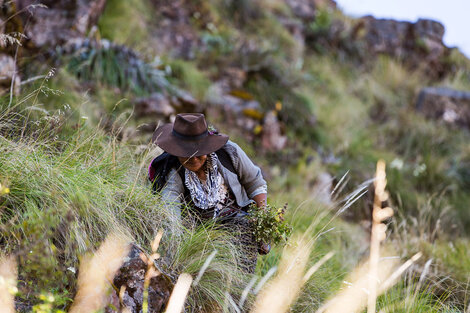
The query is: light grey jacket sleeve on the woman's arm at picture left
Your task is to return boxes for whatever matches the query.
[161,169,184,218]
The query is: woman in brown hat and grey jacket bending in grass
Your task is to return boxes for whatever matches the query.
[149,113,270,273]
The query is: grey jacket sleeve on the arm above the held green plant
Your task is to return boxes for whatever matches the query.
[228,141,268,199]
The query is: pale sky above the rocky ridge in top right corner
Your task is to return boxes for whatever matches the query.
[336,0,470,57]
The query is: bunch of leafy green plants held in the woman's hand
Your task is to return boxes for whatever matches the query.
[248,204,292,245]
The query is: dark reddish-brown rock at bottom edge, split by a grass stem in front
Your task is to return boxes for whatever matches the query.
[105,246,173,313]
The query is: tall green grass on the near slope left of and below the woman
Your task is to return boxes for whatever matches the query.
[0,95,248,309]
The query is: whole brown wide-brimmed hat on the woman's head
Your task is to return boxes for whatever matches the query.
[153,113,228,158]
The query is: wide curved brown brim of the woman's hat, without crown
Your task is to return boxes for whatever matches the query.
[153,123,229,158]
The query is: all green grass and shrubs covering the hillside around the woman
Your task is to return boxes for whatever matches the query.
[0,0,470,312]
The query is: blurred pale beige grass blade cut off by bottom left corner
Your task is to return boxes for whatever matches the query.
[0,256,18,313]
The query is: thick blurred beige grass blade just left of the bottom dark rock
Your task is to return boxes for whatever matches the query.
[69,234,129,313]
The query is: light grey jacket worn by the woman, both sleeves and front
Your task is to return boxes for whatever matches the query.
[161,140,267,216]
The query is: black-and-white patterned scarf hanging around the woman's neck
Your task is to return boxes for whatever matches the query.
[184,153,227,211]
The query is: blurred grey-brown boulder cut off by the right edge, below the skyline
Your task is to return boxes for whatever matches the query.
[416,87,470,129]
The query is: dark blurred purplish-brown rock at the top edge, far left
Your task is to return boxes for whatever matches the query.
[15,0,106,49]
